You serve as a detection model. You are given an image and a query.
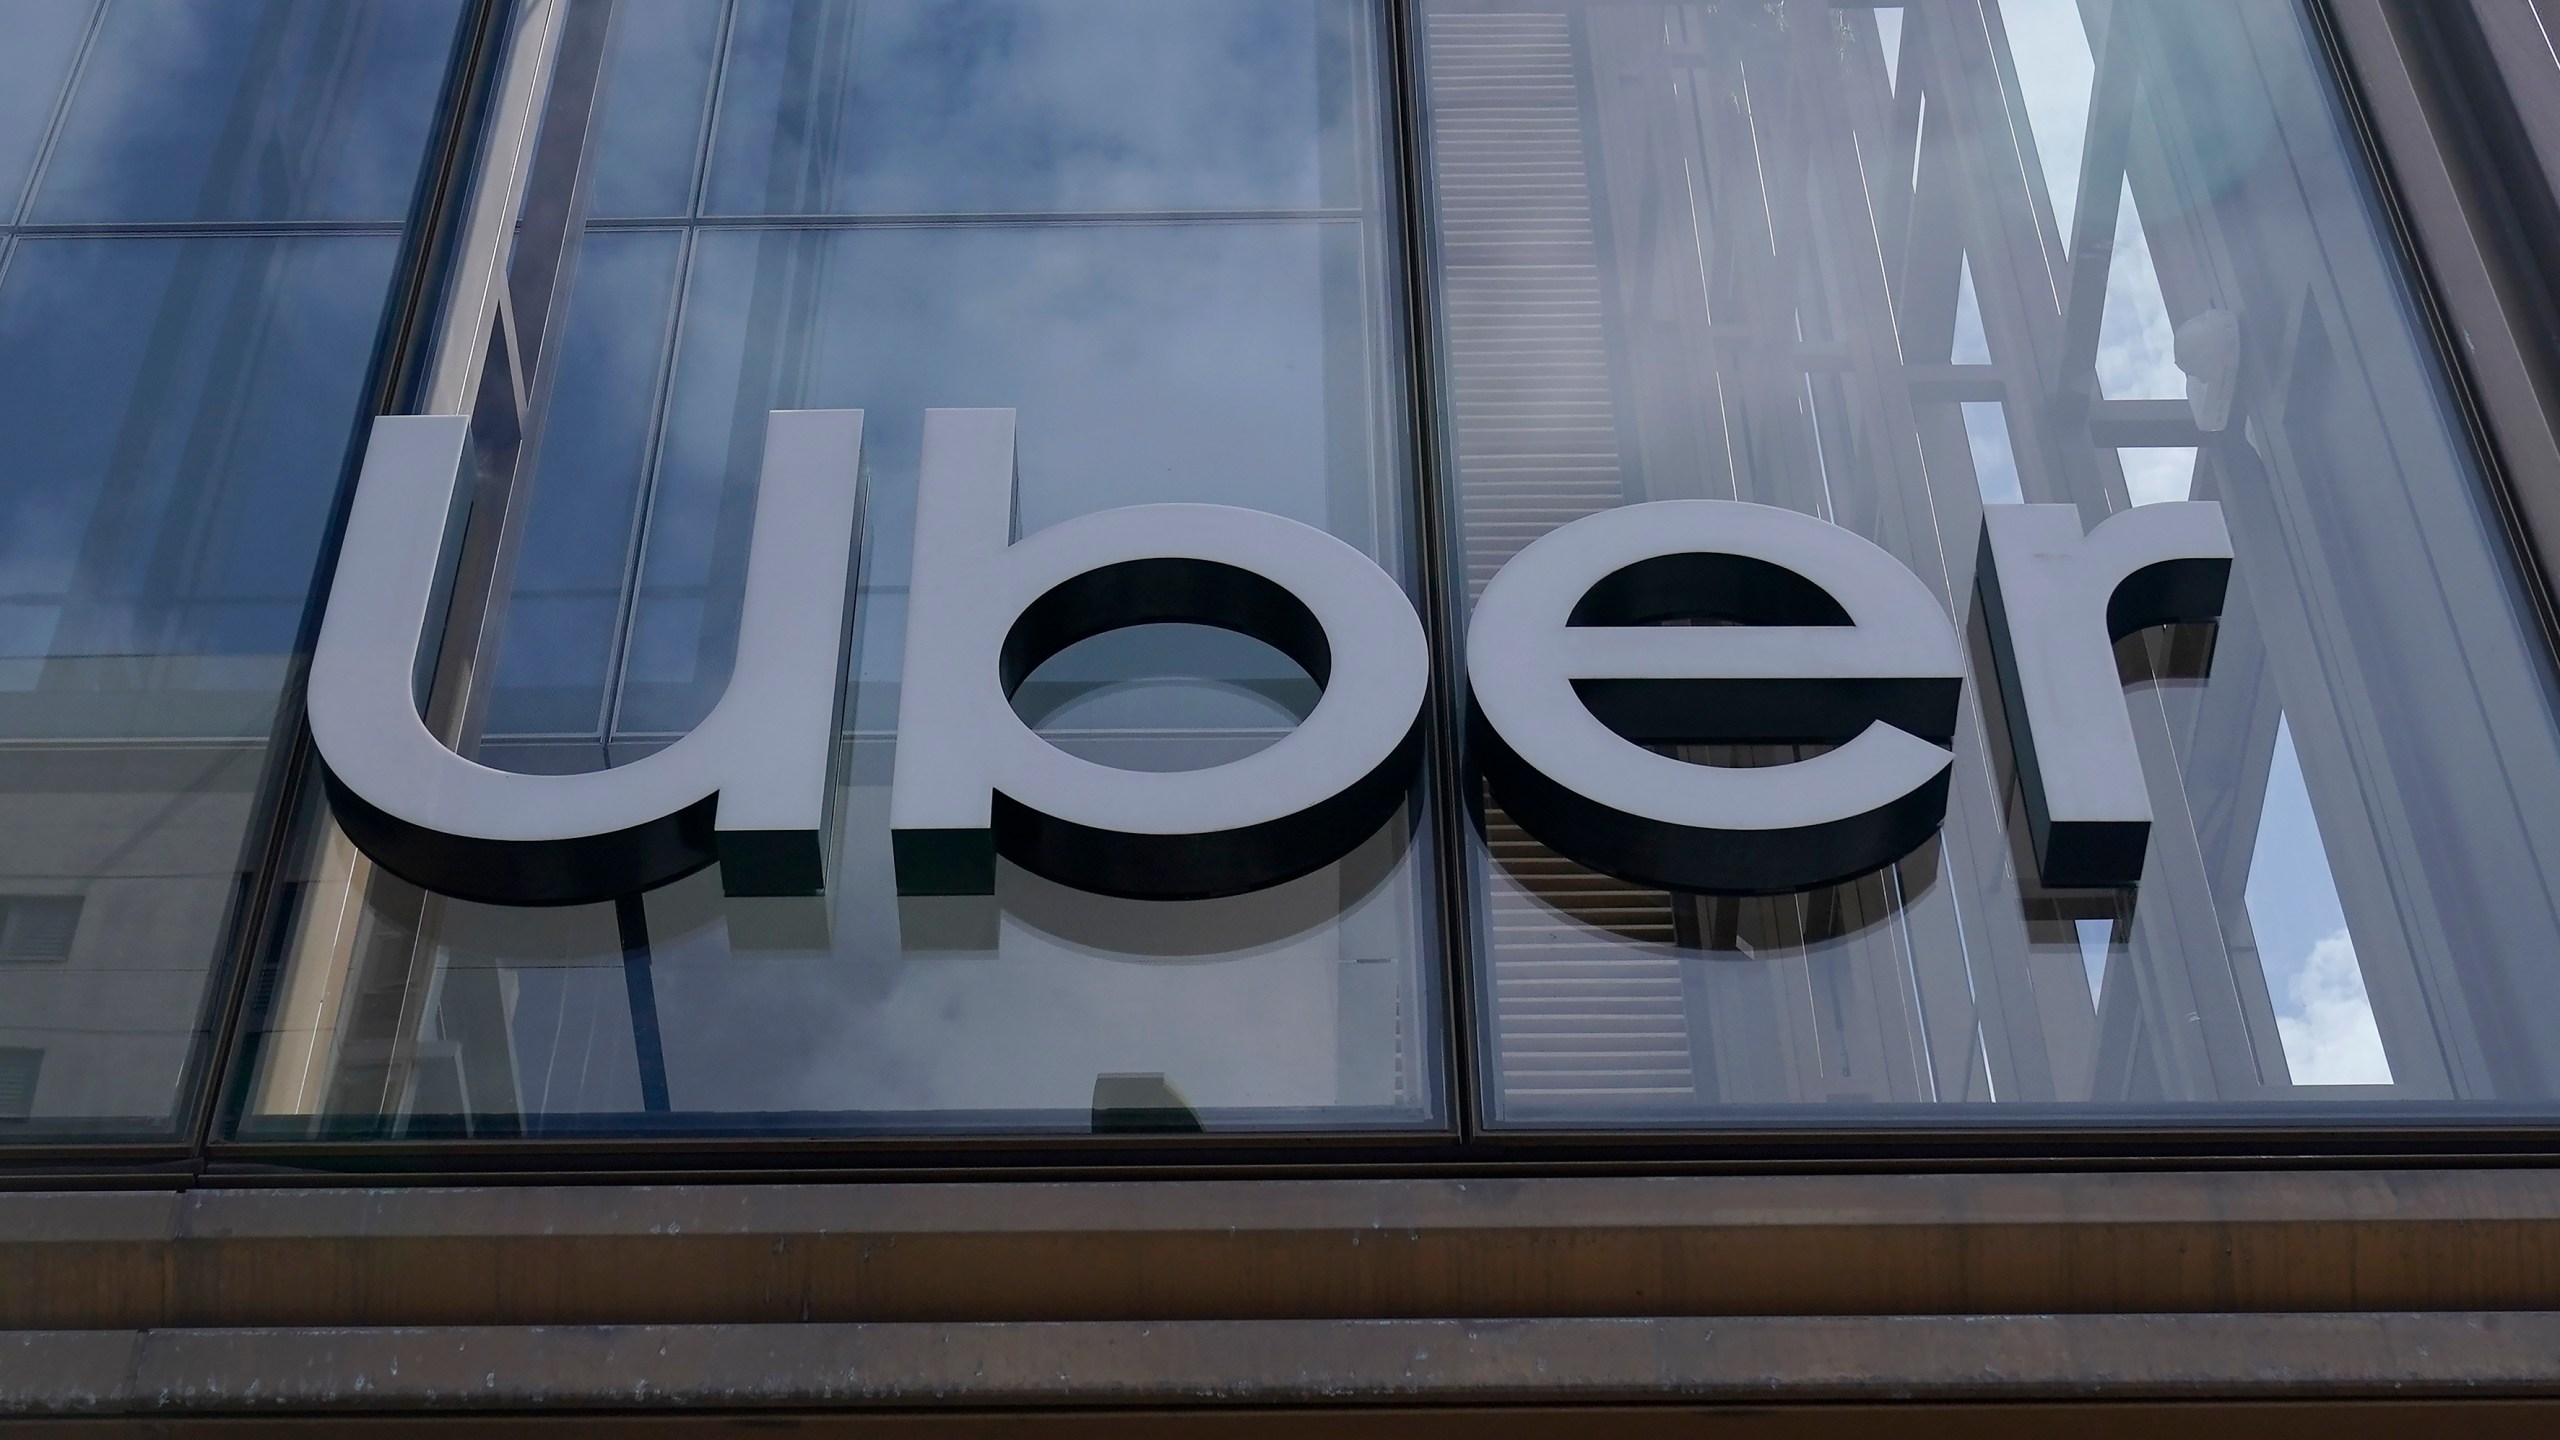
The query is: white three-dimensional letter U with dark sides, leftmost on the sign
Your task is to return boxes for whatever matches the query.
[310,410,863,904]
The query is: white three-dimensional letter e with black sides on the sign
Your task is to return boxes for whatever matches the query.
[1467,500,1964,894]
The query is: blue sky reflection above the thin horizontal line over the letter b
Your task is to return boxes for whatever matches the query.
[707,0,1326,215]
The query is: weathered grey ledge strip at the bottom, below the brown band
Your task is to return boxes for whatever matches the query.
[0,1312,2560,1417]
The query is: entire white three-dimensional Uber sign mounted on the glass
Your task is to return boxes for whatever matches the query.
[310,410,2230,904]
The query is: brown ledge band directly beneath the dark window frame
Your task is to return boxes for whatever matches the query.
[0,1171,2560,1330]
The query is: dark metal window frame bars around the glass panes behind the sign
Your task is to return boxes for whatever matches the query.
[0,0,2560,1186]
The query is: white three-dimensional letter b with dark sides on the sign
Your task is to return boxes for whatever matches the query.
[888,410,1431,897]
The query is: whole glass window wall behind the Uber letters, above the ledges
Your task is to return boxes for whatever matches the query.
[0,0,2560,1147]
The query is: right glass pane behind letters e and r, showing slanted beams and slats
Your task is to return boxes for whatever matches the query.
[1421,0,2560,1127]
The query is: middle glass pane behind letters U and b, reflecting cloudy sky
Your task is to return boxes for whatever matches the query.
[238,0,1446,1138]
